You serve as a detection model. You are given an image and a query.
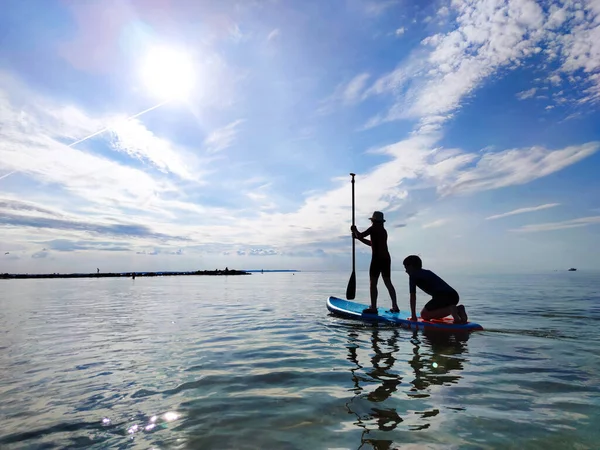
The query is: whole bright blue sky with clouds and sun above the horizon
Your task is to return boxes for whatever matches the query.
[0,0,600,273]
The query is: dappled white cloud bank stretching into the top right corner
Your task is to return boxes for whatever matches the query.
[358,0,600,128]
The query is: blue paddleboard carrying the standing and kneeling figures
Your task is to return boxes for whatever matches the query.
[327,297,483,331]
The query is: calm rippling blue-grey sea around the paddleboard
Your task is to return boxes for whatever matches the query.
[0,272,600,450]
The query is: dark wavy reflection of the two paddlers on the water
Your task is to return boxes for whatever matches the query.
[346,325,469,449]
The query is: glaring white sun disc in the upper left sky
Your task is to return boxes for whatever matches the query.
[141,46,195,100]
